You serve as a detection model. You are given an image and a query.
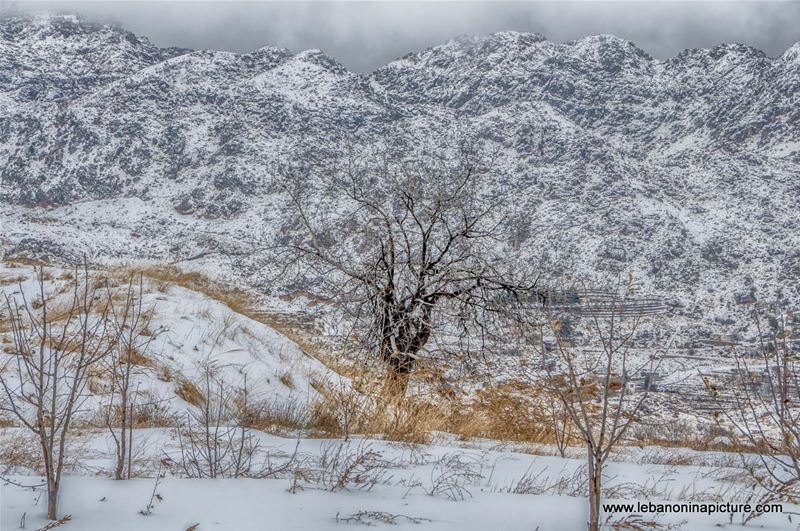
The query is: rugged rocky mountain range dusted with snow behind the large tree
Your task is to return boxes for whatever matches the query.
[0,16,800,332]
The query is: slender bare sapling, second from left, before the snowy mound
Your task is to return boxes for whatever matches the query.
[104,274,155,479]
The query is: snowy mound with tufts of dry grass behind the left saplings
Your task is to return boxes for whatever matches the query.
[0,266,334,424]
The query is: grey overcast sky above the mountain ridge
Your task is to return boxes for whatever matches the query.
[0,0,800,71]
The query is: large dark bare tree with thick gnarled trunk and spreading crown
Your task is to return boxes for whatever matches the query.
[283,140,536,393]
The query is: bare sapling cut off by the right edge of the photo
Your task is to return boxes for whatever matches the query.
[706,309,800,503]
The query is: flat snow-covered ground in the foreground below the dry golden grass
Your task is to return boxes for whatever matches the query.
[0,430,797,531]
